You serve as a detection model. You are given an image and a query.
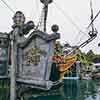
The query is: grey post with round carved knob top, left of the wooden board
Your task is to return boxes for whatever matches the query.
[10,11,25,100]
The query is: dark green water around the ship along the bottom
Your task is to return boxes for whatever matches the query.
[0,80,100,100]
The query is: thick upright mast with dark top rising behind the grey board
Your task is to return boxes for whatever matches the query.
[40,0,52,32]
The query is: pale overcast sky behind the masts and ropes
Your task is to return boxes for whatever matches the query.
[0,0,100,54]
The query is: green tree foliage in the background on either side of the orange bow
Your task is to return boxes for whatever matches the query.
[55,41,100,66]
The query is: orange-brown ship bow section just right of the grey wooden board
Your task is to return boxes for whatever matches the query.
[53,54,77,79]
